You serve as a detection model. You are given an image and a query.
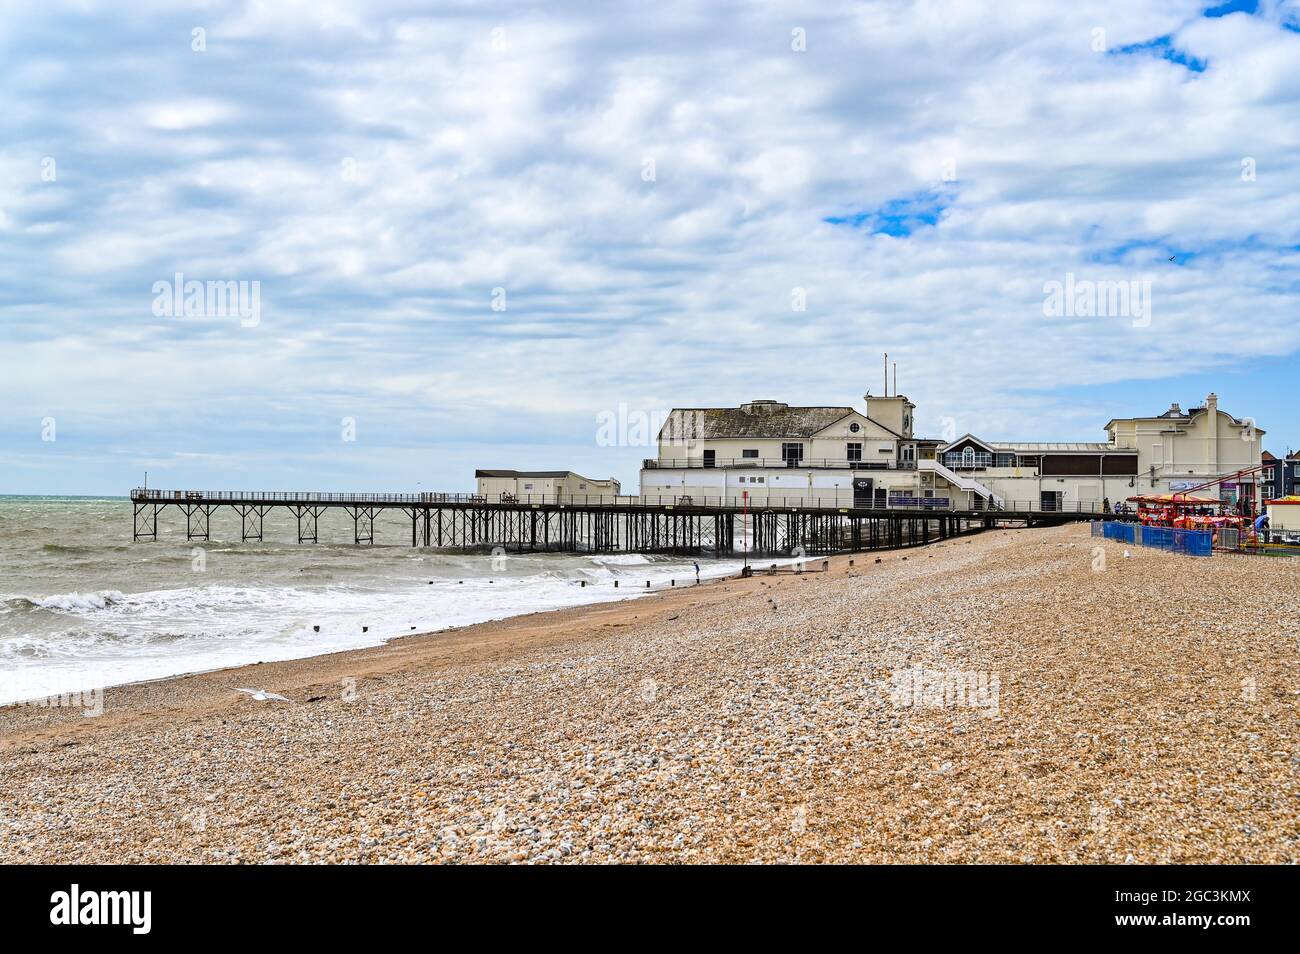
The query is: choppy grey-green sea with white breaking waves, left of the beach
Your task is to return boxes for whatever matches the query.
[0,496,741,704]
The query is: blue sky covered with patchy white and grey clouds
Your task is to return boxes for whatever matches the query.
[0,0,1300,494]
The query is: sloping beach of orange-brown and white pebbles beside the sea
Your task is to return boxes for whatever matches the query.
[0,526,1300,863]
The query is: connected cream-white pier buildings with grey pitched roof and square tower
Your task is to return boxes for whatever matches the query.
[641,394,1264,511]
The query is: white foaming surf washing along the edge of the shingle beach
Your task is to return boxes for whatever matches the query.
[0,551,736,704]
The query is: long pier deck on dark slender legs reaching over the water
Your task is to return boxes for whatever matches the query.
[131,487,1097,556]
